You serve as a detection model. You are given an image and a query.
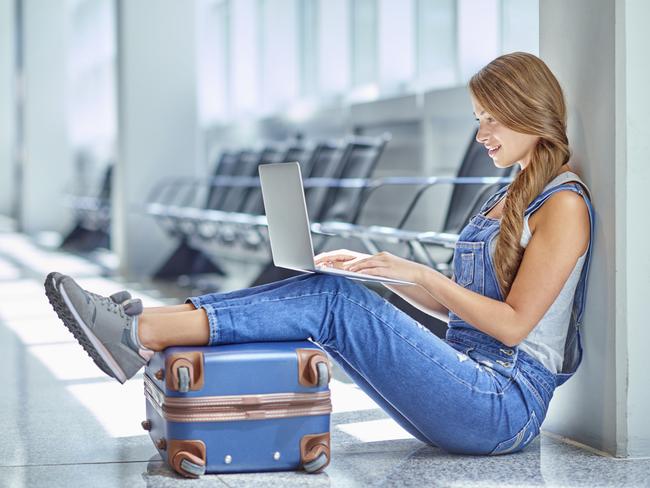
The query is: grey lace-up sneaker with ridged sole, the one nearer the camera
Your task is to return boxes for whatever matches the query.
[45,273,146,383]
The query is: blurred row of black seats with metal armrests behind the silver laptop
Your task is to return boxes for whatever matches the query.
[147,134,390,278]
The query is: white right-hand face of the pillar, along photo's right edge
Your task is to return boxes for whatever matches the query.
[616,0,650,457]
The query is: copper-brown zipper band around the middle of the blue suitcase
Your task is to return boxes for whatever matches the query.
[144,375,332,422]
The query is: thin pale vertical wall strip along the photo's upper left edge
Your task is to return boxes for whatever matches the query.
[0,0,15,215]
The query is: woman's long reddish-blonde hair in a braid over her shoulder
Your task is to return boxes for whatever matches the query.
[469,52,570,298]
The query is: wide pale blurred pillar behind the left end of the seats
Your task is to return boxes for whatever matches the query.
[112,0,198,278]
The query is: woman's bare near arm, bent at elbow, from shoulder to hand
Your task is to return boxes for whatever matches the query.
[349,191,590,347]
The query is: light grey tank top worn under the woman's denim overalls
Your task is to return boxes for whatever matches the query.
[486,171,587,373]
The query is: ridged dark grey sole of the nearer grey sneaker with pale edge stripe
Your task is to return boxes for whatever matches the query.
[45,273,128,383]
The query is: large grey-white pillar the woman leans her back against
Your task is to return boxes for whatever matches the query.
[540,0,650,457]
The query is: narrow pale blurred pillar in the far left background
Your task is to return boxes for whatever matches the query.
[20,0,73,233]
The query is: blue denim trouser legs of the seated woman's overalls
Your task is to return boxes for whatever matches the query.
[188,274,552,454]
